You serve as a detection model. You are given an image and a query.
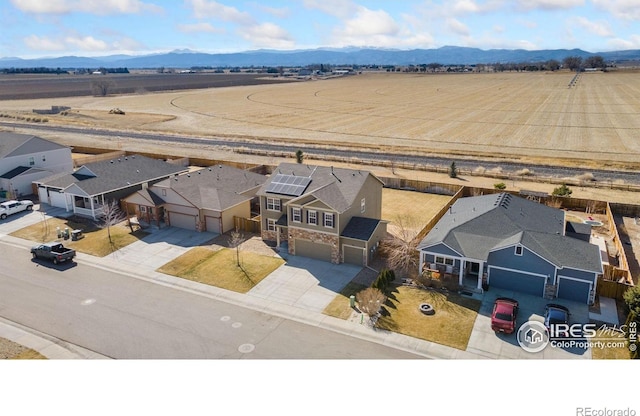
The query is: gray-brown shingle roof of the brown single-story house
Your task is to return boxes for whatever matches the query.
[157,165,267,211]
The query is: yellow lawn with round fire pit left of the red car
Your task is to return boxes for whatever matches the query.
[378,286,480,350]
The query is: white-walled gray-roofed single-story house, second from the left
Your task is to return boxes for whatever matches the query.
[34,155,188,219]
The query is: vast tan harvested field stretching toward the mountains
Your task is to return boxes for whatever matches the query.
[0,71,640,167]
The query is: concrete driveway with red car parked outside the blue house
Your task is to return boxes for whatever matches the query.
[467,288,591,359]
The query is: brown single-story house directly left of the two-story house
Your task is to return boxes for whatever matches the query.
[125,165,267,234]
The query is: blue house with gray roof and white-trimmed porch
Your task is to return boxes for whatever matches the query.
[418,193,602,304]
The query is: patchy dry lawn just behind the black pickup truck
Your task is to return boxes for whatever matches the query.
[11,218,148,257]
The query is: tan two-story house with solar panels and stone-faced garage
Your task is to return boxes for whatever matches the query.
[257,163,387,266]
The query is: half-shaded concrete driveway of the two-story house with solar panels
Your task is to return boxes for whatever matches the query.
[248,256,362,312]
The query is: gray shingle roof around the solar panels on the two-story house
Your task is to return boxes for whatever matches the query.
[258,163,379,213]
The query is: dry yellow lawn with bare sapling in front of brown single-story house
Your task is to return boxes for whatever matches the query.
[158,247,284,293]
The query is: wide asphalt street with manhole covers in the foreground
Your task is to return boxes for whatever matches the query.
[0,242,422,359]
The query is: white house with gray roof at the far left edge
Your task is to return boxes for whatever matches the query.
[0,131,73,198]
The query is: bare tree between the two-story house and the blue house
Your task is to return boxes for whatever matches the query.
[380,215,420,274]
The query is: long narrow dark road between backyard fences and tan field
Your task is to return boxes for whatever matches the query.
[0,121,640,184]
